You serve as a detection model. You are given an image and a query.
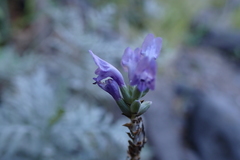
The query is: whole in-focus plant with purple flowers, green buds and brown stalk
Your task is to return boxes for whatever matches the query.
[89,34,162,160]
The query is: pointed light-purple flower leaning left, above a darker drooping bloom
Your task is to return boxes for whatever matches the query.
[89,51,125,87]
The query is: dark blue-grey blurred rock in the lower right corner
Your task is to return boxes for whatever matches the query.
[177,87,240,160]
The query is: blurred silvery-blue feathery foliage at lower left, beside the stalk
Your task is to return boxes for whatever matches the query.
[0,62,127,160]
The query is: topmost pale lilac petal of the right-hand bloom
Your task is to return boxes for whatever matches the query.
[141,34,162,59]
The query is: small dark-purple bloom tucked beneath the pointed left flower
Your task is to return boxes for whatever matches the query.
[97,79,122,101]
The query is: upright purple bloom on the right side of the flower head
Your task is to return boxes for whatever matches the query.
[122,34,162,91]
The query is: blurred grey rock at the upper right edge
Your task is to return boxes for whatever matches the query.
[190,6,240,66]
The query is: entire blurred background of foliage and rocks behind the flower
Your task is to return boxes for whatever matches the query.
[0,0,240,160]
